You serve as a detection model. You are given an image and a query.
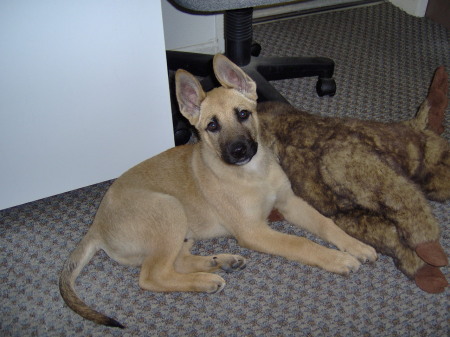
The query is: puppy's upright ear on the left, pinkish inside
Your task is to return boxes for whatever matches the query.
[175,69,206,125]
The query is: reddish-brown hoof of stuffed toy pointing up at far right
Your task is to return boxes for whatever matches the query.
[427,66,448,135]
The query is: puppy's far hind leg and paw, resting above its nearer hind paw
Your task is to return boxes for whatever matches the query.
[175,239,247,273]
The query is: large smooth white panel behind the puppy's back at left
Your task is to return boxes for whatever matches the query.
[0,0,173,209]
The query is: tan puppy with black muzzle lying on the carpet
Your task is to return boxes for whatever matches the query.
[60,55,377,327]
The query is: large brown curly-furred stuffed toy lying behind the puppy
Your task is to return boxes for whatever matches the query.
[258,67,450,293]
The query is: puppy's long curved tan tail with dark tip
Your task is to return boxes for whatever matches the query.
[59,233,125,329]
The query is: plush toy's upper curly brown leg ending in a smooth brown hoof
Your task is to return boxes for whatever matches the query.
[321,142,448,288]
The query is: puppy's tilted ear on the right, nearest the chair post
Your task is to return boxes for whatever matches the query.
[213,54,258,101]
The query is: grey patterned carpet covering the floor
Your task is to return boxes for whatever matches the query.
[0,4,450,337]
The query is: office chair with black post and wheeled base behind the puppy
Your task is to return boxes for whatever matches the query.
[166,0,336,145]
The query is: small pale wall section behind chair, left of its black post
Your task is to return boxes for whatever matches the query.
[161,0,225,54]
